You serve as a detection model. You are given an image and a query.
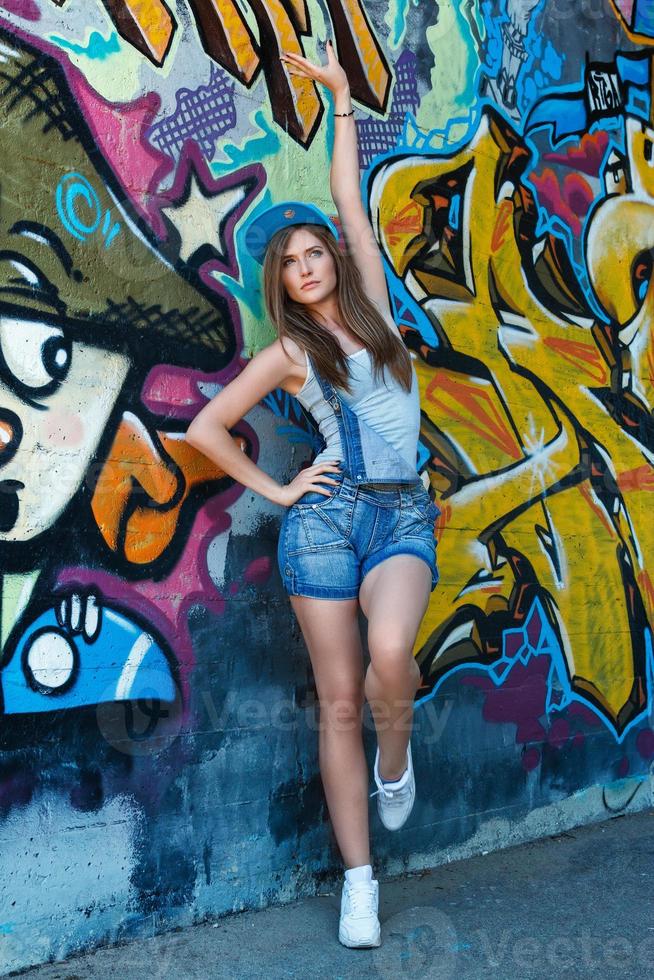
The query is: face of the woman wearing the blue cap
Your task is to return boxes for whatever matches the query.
[282,228,337,306]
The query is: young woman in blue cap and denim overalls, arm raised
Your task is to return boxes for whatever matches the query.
[187,43,438,947]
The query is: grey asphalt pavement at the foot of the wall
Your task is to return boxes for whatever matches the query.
[14,811,654,980]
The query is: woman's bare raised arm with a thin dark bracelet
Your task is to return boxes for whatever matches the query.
[282,41,397,320]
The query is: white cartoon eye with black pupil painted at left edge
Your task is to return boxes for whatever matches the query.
[0,316,71,397]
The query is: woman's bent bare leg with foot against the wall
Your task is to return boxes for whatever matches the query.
[359,555,431,780]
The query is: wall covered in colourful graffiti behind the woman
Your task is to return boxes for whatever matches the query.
[0,0,654,970]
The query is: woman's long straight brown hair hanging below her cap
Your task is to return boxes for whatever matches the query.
[263,224,412,392]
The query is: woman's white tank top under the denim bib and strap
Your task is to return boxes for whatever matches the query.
[295,347,420,468]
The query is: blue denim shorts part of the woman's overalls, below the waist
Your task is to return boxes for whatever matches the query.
[277,473,440,599]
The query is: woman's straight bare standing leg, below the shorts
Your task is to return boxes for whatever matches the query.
[290,596,370,868]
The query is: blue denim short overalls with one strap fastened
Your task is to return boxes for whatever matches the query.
[277,355,440,599]
